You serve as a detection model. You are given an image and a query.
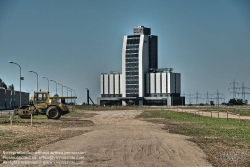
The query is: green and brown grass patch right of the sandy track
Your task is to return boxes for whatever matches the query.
[139,110,250,166]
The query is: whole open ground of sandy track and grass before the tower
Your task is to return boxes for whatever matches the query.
[0,105,250,167]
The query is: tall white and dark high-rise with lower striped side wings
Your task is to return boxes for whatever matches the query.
[97,26,185,105]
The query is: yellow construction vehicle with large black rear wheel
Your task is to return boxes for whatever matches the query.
[14,90,76,119]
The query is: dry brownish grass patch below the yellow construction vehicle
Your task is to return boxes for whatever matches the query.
[0,111,94,164]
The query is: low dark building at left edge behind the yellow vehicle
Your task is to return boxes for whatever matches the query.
[0,88,29,110]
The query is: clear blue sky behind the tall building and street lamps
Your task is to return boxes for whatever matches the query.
[0,0,250,103]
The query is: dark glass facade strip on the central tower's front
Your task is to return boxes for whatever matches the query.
[125,35,140,97]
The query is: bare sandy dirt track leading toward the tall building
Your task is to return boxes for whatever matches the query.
[2,110,212,167]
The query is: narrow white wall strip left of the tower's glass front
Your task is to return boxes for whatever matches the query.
[121,36,128,97]
